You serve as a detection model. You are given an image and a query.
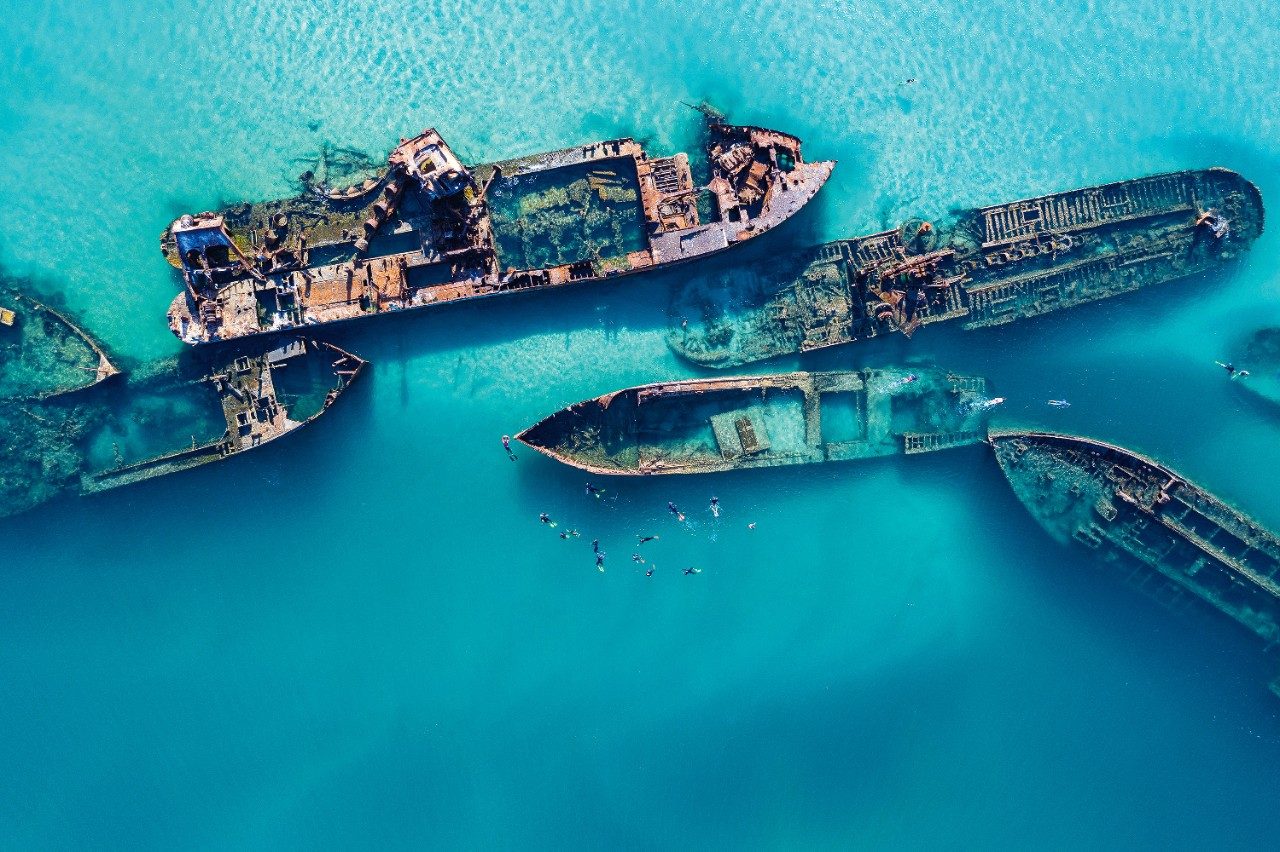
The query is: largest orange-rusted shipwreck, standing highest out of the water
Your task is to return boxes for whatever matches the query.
[161,119,835,344]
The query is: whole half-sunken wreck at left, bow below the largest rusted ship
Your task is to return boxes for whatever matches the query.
[0,339,365,517]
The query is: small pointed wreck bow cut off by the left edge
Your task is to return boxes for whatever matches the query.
[0,285,119,400]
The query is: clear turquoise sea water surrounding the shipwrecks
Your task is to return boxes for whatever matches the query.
[0,0,1280,848]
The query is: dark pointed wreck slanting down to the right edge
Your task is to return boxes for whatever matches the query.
[991,431,1280,695]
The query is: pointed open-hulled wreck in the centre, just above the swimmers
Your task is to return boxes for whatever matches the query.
[518,368,998,475]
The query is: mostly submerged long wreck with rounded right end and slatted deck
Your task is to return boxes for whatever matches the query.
[669,169,1263,367]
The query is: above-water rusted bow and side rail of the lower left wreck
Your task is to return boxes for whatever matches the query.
[81,338,365,494]
